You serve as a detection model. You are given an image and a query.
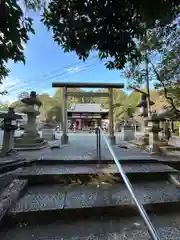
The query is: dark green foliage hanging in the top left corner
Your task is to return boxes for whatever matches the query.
[0,0,34,89]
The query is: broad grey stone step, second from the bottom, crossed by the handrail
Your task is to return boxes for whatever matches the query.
[8,181,180,223]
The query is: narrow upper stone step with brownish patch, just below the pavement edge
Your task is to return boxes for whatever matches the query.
[17,162,178,184]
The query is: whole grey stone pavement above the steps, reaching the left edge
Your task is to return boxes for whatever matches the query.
[0,133,178,165]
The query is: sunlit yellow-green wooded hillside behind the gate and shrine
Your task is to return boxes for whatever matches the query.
[11,88,167,122]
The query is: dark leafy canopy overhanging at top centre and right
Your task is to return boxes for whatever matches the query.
[42,0,179,69]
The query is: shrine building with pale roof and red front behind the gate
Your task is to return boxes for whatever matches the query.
[67,103,109,130]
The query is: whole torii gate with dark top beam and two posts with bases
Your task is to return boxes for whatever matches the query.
[52,82,124,145]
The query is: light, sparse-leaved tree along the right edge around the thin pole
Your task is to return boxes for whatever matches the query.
[124,15,180,114]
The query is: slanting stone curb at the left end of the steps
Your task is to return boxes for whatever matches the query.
[0,179,28,222]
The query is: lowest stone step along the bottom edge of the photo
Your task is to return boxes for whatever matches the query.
[0,214,180,240]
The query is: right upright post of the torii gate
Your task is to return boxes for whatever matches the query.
[109,88,116,145]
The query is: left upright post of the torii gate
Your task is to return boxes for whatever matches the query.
[61,87,68,144]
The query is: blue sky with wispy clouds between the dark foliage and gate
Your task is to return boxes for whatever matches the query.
[1,10,129,103]
